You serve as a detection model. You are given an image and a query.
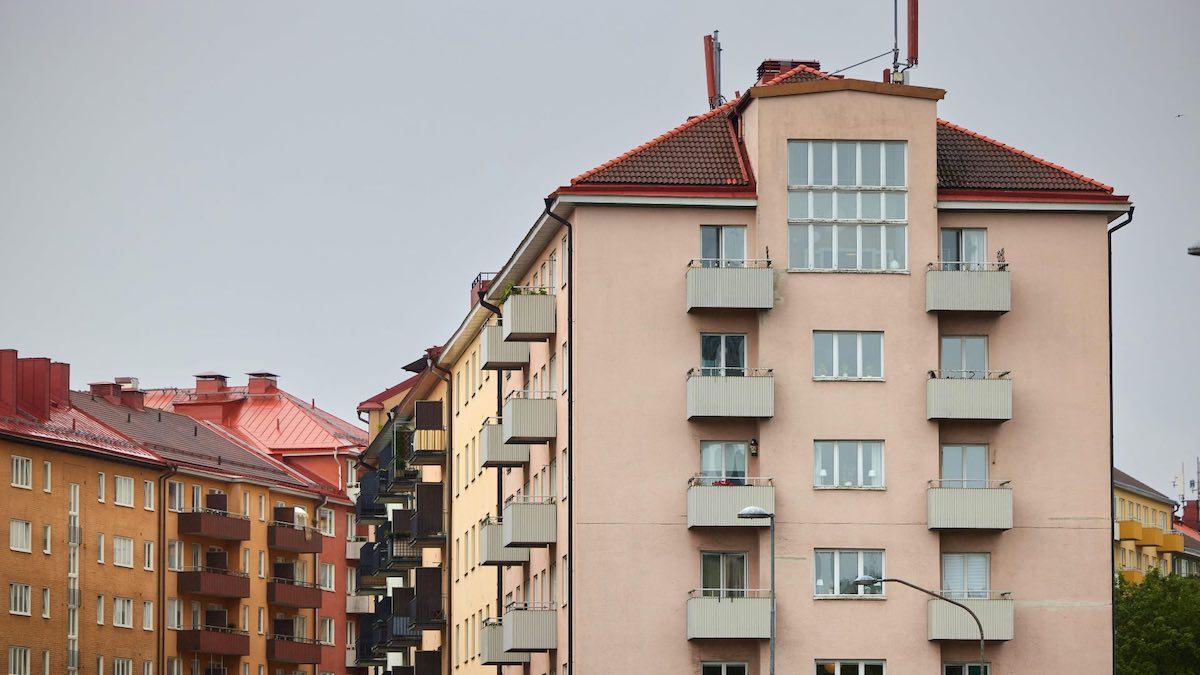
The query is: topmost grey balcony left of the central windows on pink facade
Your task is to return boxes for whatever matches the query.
[686,259,775,312]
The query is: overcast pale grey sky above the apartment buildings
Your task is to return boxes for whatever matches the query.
[0,0,1200,495]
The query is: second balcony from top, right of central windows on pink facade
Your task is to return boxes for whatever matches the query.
[925,370,1013,422]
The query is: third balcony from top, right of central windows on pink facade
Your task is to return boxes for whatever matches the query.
[925,480,1013,530]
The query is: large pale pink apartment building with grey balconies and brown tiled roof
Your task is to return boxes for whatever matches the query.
[350,60,1130,675]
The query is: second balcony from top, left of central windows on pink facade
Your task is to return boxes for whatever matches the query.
[688,368,775,419]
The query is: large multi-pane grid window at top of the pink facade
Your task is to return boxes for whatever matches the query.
[787,141,908,271]
